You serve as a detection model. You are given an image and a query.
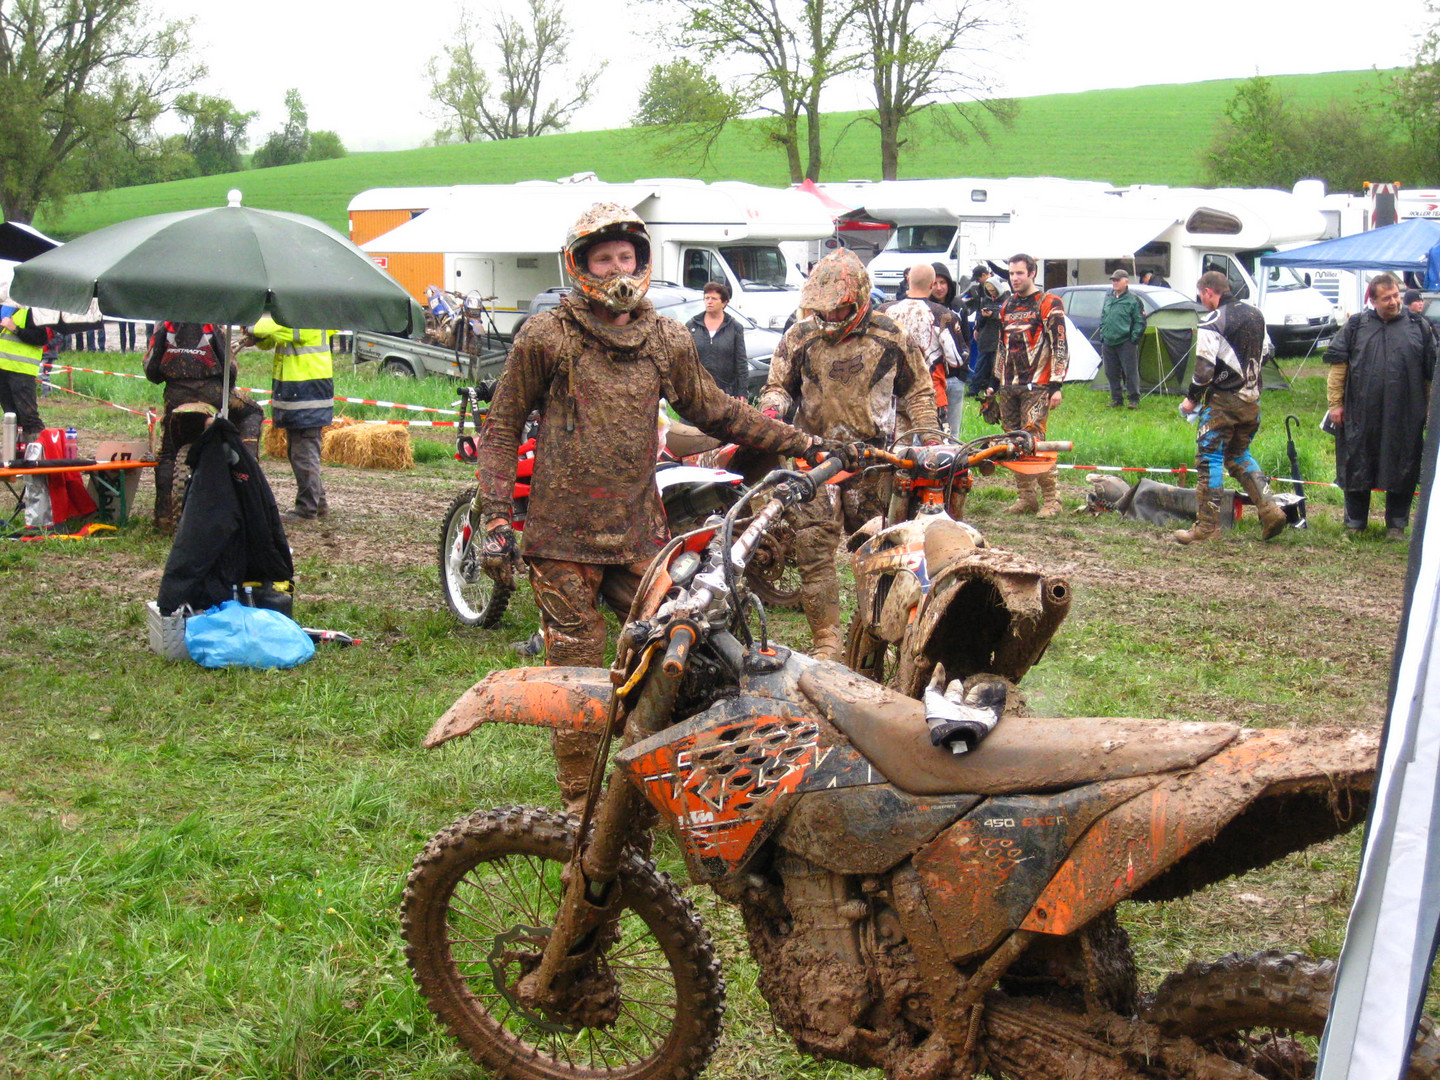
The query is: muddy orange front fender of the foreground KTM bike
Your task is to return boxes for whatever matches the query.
[423,667,611,749]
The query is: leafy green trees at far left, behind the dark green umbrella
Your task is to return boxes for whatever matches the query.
[0,0,346,222]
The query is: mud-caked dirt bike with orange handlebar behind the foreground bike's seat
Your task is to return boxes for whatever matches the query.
[845,431,1073,697]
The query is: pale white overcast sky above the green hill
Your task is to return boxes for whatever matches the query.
[151,0,1424,150]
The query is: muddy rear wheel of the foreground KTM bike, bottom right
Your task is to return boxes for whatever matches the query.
[1142,949,1440,1080]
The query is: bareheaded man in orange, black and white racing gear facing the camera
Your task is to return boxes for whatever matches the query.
[982,253,1070,517]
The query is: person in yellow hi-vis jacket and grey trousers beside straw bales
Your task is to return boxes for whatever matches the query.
[246,315,336,521]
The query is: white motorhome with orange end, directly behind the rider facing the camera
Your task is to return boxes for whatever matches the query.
[350,174,835,334]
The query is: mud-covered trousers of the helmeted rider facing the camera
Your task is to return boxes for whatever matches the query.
[526,559,649,812]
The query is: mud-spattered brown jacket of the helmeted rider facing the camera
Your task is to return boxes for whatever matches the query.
[475,297,811,564]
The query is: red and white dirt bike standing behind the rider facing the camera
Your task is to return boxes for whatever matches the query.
[435,383,799,629]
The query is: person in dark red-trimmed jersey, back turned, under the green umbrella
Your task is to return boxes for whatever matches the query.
[144,323,265,534]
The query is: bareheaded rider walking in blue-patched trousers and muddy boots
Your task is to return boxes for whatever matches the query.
[1174,271,1284,544]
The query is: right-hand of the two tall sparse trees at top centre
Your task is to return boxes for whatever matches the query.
[858,0,1015,180]
